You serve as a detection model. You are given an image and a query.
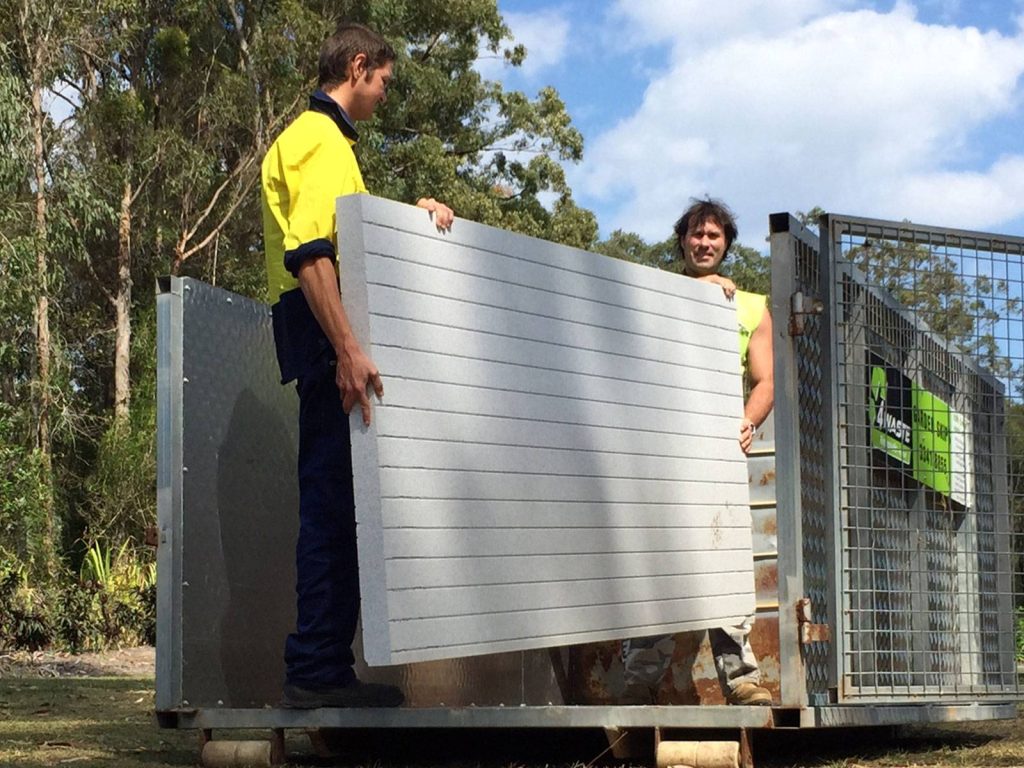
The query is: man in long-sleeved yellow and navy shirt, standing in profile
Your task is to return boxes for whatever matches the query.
[262,24,454,709]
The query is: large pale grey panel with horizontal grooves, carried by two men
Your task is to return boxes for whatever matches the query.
[338,196,754,666]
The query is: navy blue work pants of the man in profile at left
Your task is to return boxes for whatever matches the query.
[285,360,359,686]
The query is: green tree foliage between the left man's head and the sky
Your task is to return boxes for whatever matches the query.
[356,0,597,248]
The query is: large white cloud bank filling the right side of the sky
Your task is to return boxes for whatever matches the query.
[570,0,1024,240]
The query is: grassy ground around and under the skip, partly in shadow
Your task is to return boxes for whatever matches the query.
[0,677,1024,768]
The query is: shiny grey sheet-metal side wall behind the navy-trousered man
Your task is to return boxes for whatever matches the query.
[157,279,298,709]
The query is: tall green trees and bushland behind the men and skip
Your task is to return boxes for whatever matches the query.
[0,0,1024,671]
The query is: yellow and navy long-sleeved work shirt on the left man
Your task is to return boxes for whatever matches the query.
[261,91,367,382]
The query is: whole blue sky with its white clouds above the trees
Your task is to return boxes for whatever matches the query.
[479,0,1024,249]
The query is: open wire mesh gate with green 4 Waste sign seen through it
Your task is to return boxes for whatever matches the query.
[823,215,1024,701]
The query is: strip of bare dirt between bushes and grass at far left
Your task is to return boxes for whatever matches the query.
[0,645,156,678]
